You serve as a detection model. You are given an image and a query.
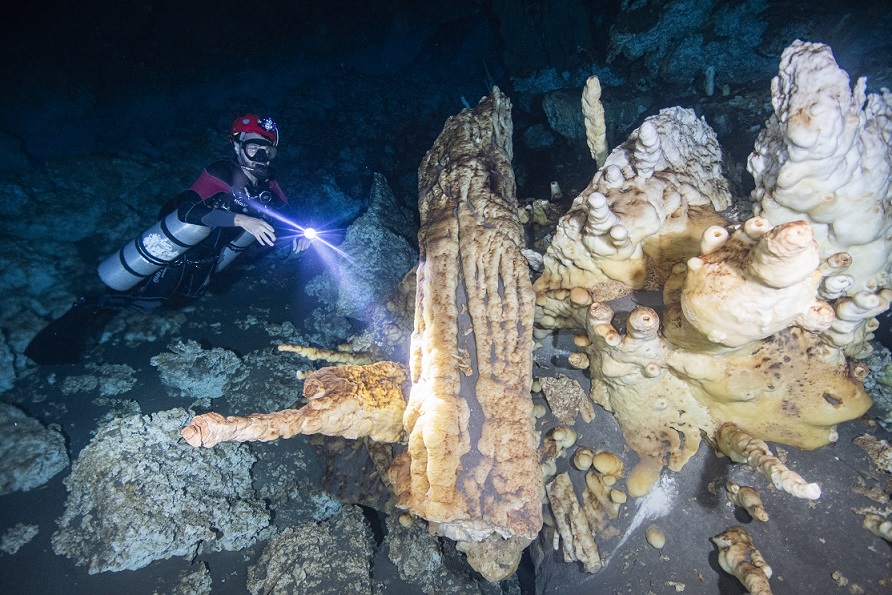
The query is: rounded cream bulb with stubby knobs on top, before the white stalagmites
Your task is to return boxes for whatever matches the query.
[663,217,833,351]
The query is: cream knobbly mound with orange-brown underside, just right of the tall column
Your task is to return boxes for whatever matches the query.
[534,106,731,328]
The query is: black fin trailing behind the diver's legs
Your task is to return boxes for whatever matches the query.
[25,301,109,366]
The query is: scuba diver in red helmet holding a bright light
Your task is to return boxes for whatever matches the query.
[25,114,310,364]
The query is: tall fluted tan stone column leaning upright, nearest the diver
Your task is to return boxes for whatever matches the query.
[391,89,542,580]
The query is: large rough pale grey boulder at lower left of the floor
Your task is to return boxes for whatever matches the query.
[52,409,270,574]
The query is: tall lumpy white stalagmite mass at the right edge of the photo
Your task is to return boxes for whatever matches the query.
[747,40,892,357]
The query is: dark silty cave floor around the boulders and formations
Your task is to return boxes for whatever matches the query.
[0,249,892,594]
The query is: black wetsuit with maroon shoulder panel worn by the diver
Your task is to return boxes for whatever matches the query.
[98,159,288,311]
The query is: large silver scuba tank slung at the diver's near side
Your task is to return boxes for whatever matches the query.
[98,210,214,291]
